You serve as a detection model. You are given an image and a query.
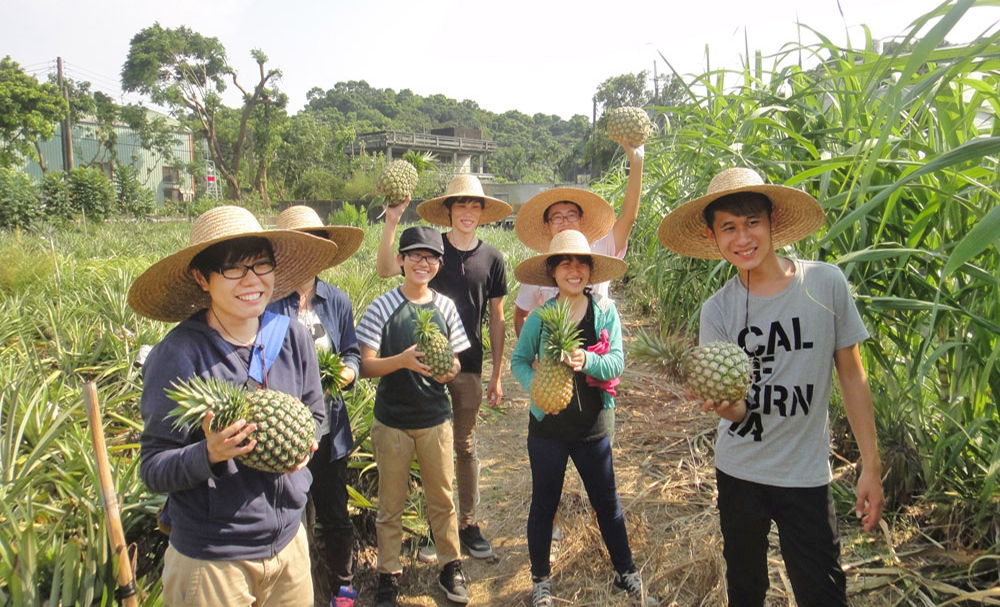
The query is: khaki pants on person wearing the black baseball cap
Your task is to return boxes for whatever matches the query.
[371,420,459,573]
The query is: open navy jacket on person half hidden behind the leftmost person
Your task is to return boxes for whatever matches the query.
[267,278,361,461]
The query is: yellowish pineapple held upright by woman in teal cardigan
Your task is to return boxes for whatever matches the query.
[531,300,582,415]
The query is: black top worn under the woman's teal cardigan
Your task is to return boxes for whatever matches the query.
[528,295,614,441]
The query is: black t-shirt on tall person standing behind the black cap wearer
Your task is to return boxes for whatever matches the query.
[430,234,507,373]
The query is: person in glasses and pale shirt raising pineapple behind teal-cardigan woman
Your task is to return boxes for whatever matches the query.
[514,141,645,335]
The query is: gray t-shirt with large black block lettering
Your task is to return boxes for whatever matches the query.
[699,260,868,487]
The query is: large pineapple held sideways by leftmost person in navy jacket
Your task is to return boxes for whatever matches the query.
[167,377,316,473]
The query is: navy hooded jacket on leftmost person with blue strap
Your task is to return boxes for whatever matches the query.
[140,310,325,560]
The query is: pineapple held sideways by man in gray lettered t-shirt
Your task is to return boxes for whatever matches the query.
[629,331,753,402]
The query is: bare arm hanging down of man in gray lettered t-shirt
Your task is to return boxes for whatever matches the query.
[833,344,885,531]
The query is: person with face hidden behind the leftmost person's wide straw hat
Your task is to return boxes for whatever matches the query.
[267,205,365,607]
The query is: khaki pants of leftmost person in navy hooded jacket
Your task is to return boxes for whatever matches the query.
[163,525,313,607]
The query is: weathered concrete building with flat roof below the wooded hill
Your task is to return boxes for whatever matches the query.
[352,128,497,176]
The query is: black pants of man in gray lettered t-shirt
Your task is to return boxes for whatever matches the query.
[716,469,847,607]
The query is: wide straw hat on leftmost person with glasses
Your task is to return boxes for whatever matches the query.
[128,206,337,322]
